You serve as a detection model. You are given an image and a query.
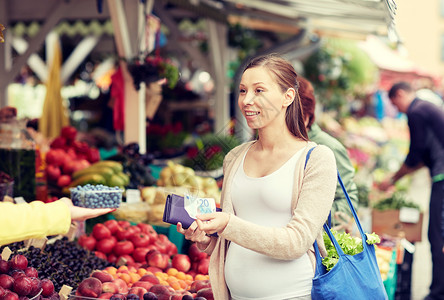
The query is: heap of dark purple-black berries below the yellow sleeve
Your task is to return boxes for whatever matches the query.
[0,238,113,292]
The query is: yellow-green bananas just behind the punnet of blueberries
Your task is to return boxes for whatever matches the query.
[68,160,130,189]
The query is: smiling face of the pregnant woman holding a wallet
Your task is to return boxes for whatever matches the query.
[238,67,295,129]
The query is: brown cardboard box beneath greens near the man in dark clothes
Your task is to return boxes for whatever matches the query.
[372,209,424,243]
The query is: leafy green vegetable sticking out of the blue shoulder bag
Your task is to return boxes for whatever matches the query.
[322,230,381,271]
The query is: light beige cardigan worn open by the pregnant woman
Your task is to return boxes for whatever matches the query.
[198,141,337,300]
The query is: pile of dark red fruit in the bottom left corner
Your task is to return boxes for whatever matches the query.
[0,254,59,300]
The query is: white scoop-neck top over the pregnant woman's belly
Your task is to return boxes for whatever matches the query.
[225,144,314,300]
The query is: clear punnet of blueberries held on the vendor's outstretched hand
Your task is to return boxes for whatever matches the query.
[70,184,123,208]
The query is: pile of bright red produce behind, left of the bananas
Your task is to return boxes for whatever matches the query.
[45,126,100,190]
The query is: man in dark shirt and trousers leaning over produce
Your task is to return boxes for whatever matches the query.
[380,82,444,300]
